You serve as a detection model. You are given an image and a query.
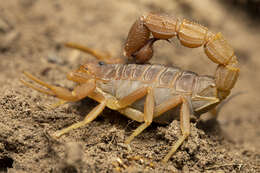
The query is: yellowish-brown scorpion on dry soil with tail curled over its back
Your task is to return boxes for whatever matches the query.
[21,13,239,162]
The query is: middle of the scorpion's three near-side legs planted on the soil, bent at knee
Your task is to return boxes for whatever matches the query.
[125,88,155,144]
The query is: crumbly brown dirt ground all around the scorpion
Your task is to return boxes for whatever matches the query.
[0,0,260,172]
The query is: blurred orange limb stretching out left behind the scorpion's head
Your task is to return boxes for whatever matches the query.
[65,43,126,64]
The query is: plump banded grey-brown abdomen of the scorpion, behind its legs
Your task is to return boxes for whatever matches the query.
[92,64,219,123]
